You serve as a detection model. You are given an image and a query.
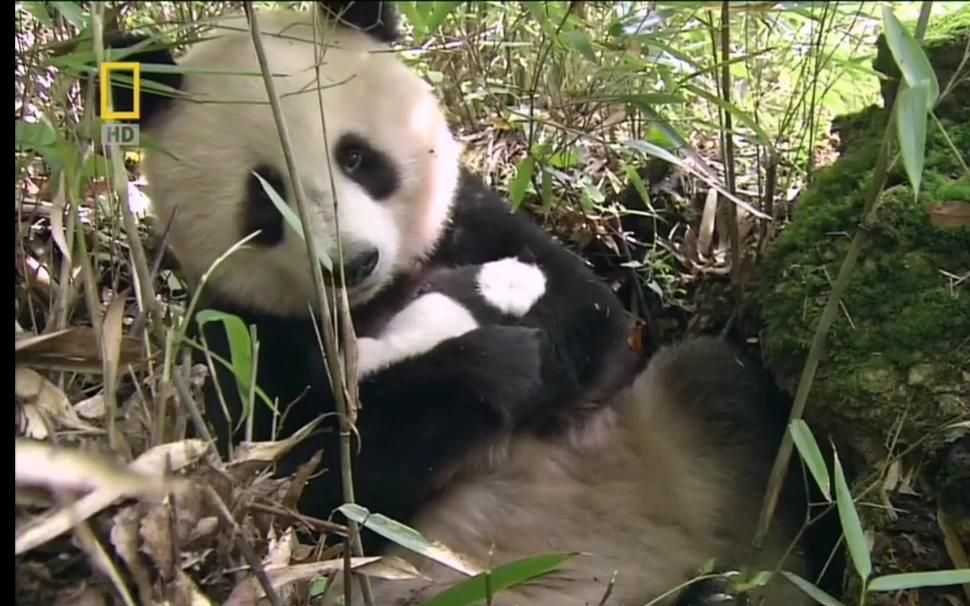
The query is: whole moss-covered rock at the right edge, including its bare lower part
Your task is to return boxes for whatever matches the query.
[755,13,970,606]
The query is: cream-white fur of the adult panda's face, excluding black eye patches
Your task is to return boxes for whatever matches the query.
[146,11,460,315]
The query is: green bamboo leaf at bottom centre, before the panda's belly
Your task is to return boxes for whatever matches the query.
[421,553,575,606]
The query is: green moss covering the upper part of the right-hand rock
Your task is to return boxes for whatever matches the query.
[757,111,970,446]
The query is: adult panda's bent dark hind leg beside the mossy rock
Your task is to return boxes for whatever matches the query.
[633,337,807,606]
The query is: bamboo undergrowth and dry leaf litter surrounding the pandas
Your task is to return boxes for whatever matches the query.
[15,1,970,606]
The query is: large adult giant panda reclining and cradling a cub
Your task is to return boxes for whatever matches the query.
[98,2,808,606]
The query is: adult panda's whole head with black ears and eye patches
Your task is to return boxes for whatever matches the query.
[113,2,460,315]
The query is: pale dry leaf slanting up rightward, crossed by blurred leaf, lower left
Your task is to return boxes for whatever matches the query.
[14,440,208,555]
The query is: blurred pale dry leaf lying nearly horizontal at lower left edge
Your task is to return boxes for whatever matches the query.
[15,438,180,497]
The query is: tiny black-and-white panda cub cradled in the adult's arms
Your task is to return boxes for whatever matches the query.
[357,257,546,381]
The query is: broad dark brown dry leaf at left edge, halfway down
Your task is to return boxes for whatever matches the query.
[16,326,143,374]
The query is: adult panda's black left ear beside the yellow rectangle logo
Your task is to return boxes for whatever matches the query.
[95,33,182,126]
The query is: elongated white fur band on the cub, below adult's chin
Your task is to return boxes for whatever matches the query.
[357,293,478,378]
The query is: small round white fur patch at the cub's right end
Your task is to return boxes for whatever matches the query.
[478,257,546,317]
